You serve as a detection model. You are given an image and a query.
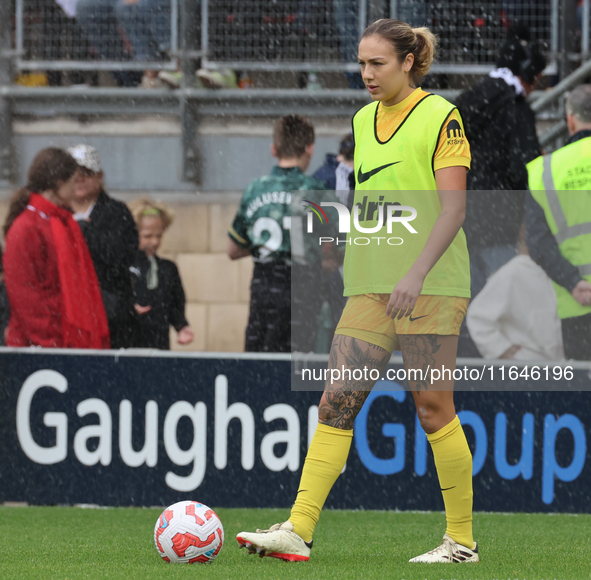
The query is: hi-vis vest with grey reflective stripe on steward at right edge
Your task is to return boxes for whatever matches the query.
[527,137,591,319]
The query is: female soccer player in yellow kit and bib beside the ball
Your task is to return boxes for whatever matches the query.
[237,20,478,562]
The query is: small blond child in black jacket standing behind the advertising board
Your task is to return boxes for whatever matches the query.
[130,199,195,350]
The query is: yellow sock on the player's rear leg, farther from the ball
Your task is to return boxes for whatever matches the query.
[427,415,474,548]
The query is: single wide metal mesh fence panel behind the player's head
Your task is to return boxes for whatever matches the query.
[202,0,558,72]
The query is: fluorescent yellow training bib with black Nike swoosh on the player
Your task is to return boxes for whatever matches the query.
[343,95,470,298]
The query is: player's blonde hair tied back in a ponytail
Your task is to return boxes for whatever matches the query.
[362,18,437,78]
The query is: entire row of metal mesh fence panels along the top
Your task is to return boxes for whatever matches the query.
[10,0,564,72]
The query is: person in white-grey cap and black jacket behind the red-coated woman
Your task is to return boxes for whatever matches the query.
[68,145,138,349]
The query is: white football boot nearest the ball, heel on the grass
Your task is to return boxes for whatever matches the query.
[236,520,312,562]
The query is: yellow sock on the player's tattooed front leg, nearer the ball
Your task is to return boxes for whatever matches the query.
[289,423,353,542]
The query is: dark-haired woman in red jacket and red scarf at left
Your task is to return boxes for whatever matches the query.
[4,148,110,348]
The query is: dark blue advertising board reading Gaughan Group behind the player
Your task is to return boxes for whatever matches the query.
[0,349,591,513]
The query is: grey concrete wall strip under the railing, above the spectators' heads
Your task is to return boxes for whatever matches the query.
[14,117,351,192]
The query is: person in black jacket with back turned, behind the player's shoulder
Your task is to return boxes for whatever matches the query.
[456,23,546,356]
